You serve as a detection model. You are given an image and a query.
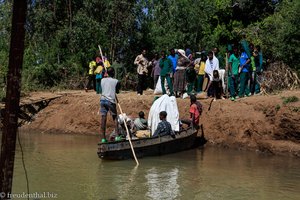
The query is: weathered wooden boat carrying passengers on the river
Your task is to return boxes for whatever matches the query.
[98,128,198,160]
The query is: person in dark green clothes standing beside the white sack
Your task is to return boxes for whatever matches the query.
[159,51,173,95]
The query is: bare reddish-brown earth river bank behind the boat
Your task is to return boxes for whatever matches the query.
[22,90,300,157]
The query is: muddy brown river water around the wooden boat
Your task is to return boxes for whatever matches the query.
[2,133,300,200]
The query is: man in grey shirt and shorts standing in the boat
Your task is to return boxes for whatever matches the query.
[100,67,120,143]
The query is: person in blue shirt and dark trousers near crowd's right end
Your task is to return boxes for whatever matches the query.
[239,47,250,98]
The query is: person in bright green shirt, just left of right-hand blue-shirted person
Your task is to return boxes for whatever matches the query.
[228,46,240,101]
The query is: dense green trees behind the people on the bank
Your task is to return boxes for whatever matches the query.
[0,0,300,90]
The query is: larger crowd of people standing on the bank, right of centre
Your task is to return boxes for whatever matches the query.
[134,39,263,100]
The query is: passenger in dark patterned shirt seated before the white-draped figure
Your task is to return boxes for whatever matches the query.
[152,111,175,137]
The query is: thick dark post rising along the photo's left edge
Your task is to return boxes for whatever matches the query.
[0,0,27,199]
